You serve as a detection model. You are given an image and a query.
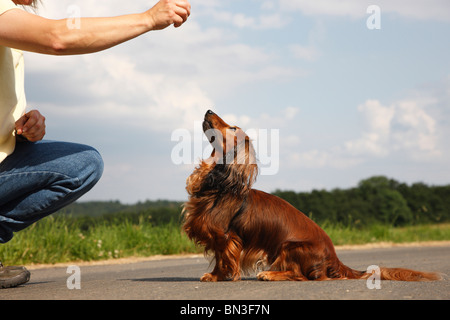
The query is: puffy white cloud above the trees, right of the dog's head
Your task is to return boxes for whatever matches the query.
[287,85,449,169]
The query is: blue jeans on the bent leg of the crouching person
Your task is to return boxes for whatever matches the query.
[0,141,103,243]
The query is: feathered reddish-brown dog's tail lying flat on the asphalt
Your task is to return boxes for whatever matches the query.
[343,266,442,281]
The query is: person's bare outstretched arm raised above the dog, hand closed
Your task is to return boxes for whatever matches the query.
[0,0,190,55]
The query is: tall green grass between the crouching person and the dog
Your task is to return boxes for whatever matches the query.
[0,216,198,265]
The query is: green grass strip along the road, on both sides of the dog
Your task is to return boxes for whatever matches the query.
[0,216,450,265]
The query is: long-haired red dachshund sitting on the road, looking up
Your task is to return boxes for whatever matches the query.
[183,110,440,281]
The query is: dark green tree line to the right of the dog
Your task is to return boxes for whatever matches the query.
[274,176,450,226]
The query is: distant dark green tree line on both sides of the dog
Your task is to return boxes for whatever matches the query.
[59,176,450,228]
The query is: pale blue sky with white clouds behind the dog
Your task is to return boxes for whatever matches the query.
[25,0,450,203]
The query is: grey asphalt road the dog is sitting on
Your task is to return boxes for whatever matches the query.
[0,246,450,302]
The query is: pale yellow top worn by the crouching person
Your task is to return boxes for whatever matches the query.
[0,0,26,162]
